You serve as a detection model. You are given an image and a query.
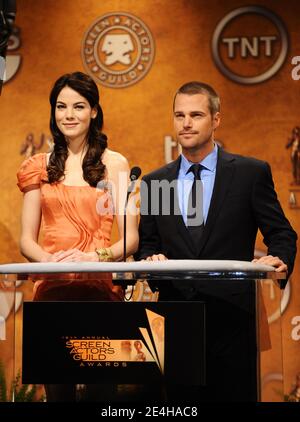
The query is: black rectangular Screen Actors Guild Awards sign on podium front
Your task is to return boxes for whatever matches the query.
[22,302,205,386]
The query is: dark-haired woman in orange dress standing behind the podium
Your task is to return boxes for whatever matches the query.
[18,72,138,401]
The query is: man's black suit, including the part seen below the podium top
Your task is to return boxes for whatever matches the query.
[138,149,297,401]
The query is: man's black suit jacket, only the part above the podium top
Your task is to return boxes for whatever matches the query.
[138,148,297,274]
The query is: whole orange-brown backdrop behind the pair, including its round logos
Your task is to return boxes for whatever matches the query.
[0,0,300,400]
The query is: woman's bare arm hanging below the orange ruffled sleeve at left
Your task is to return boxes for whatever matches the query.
[20,189,52,262]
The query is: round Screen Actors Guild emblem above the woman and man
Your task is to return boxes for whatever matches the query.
[81,12,154,88]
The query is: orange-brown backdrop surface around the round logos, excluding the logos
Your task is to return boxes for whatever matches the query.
[0,0,300,402]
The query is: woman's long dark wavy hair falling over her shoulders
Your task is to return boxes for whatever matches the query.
[47,72,107,187]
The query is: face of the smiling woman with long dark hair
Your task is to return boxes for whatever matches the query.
[55,86,97,141]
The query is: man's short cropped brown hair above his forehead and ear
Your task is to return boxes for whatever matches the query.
[173,81,220,116]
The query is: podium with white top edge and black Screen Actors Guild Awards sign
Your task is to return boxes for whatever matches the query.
[0,260,285,402]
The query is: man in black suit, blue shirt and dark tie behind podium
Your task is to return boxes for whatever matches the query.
[139,82,297,400]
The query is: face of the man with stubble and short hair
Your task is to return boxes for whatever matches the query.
[174,94,220,152]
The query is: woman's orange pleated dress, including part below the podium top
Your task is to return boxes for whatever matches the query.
[17,153,122,300]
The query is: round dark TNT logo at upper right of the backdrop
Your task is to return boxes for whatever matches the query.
[212,6,288,85]
